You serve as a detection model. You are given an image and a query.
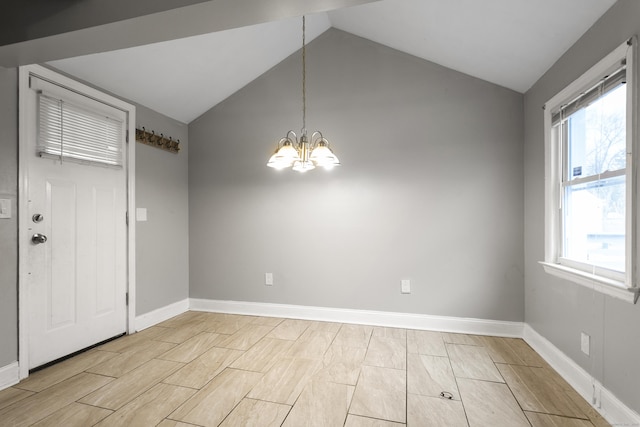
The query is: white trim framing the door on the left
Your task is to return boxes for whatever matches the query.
[18,65,136,379]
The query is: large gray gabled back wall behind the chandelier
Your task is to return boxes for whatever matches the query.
[189,29,524,321]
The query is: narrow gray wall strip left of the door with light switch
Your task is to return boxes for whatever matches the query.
[0,67,18,368]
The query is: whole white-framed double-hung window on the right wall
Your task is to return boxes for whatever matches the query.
[542,39,638,301]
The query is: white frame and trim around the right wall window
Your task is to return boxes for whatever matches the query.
[540,36,640,303]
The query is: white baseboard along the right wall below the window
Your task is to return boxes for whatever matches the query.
[523,324,640,426]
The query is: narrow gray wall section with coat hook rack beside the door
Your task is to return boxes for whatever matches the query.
[136,105,189,315]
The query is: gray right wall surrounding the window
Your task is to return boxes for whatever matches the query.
[524,0,640,412]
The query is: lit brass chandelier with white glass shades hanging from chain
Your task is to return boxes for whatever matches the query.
[267,15,340,172]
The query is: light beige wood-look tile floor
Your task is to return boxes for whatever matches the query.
[0,312,608,427]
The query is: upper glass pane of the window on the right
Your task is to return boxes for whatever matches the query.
[565,84,627,181]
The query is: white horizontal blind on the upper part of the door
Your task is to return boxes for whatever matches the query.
[36,92,124,167]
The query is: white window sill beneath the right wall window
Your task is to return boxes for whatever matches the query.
[540,261,640,304]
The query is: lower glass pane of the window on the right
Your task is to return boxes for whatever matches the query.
[563,176,625,272]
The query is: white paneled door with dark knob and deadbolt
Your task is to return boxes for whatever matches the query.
[23,72,127,369]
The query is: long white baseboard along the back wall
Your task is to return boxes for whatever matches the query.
[189,298,523,338]
